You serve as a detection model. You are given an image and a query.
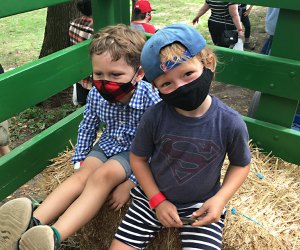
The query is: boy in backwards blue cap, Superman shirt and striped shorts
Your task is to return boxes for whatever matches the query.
[111,24,251,250]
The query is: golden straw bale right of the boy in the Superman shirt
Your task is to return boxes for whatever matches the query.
[223,148,300,250]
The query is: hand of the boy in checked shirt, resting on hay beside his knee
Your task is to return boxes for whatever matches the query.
[108,180,134,211]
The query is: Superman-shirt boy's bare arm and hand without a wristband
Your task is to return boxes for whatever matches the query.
[192,165,250,226]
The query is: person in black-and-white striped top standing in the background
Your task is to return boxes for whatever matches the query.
[192,0,244,47]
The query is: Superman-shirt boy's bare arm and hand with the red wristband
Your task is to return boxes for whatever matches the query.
[130,152,182,227]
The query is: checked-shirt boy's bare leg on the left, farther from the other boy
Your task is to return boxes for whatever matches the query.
[33,157,102,224]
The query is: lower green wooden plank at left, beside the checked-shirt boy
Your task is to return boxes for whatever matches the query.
[0,107,84,200]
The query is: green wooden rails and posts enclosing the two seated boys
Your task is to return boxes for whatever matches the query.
[0,0,300,200]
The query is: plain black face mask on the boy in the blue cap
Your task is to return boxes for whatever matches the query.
[159,68,214,111]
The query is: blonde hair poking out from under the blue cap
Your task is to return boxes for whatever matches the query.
[160,42,217,71]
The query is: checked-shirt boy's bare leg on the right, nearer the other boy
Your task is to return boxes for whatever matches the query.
[53,160,125,240]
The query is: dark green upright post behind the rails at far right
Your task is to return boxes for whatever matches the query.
[256,9,300,128]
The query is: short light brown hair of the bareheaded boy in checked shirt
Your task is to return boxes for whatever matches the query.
[90,24,146,69]
